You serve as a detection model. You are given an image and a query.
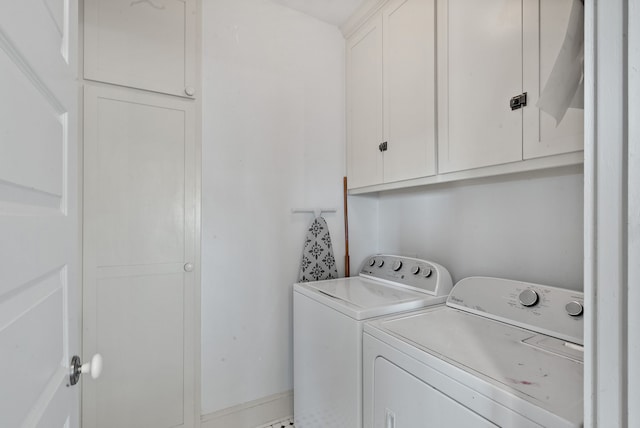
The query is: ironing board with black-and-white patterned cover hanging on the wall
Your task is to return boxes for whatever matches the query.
[298,217,338,282]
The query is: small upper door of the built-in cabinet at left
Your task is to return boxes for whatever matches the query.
[84,0,196,96]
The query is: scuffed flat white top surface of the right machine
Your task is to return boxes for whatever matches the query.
[365,306,584,425]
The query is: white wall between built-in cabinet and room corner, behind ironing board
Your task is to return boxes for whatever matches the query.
[202,0,345,414]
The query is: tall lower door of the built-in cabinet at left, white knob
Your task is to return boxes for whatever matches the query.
[83,86,199,428]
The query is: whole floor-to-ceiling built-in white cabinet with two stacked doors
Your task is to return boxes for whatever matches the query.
[82,0,200,428]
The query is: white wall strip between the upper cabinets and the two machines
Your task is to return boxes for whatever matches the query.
[350,166,583,290]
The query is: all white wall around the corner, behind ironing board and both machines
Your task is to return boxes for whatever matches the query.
[202,0,583,414]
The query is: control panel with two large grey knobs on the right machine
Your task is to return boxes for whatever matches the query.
[447,276,584,345]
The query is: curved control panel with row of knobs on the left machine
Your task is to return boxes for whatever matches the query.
[360,254,453,296]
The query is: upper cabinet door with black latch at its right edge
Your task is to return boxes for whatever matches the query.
[438,0,522,172]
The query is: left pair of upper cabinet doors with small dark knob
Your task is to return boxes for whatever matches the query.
[347,0,435,188]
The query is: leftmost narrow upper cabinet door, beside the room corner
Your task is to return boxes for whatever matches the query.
[347,15,383,188]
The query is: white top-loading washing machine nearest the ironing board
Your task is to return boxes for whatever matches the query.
[293,255,452,428]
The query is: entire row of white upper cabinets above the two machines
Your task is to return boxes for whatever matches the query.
[347,0,584,193]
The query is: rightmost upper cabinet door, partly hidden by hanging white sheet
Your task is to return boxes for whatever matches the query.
[523,0,584,159]
